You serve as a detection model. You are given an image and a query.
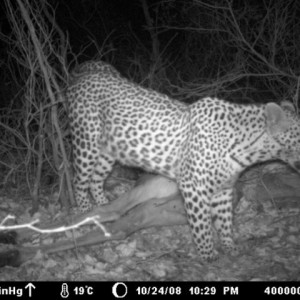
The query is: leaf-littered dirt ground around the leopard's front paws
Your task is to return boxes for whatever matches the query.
[0,163,300,281]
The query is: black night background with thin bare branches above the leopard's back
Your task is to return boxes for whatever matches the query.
[0,0,300,105]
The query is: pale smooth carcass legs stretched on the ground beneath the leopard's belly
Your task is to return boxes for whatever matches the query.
[0,175,187,266]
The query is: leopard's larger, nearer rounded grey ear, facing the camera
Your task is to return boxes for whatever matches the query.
[265,102,290,135]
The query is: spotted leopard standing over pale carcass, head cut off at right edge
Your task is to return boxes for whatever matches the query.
[66,61,300,261]
